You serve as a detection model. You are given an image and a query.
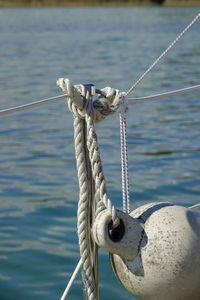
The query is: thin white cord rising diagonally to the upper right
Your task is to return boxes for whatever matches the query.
[126,13,200,96]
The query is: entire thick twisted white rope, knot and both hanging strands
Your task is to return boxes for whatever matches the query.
[57,78,123,300]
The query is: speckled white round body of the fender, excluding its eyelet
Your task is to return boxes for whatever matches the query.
[93,203,200,300]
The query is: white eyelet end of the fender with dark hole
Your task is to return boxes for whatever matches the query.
[92,209,144,259]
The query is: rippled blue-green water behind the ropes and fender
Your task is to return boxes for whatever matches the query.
[0,7,200,300]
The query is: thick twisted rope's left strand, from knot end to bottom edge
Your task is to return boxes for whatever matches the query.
[57,79,97,300]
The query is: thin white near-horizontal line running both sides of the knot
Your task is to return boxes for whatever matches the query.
[0,85,200,117]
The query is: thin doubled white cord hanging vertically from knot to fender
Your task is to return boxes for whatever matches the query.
[119,93,130,213]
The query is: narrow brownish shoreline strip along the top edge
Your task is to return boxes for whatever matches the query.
[0,0,200,8]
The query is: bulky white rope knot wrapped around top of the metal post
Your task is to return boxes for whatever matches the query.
[57,78,124,122]
